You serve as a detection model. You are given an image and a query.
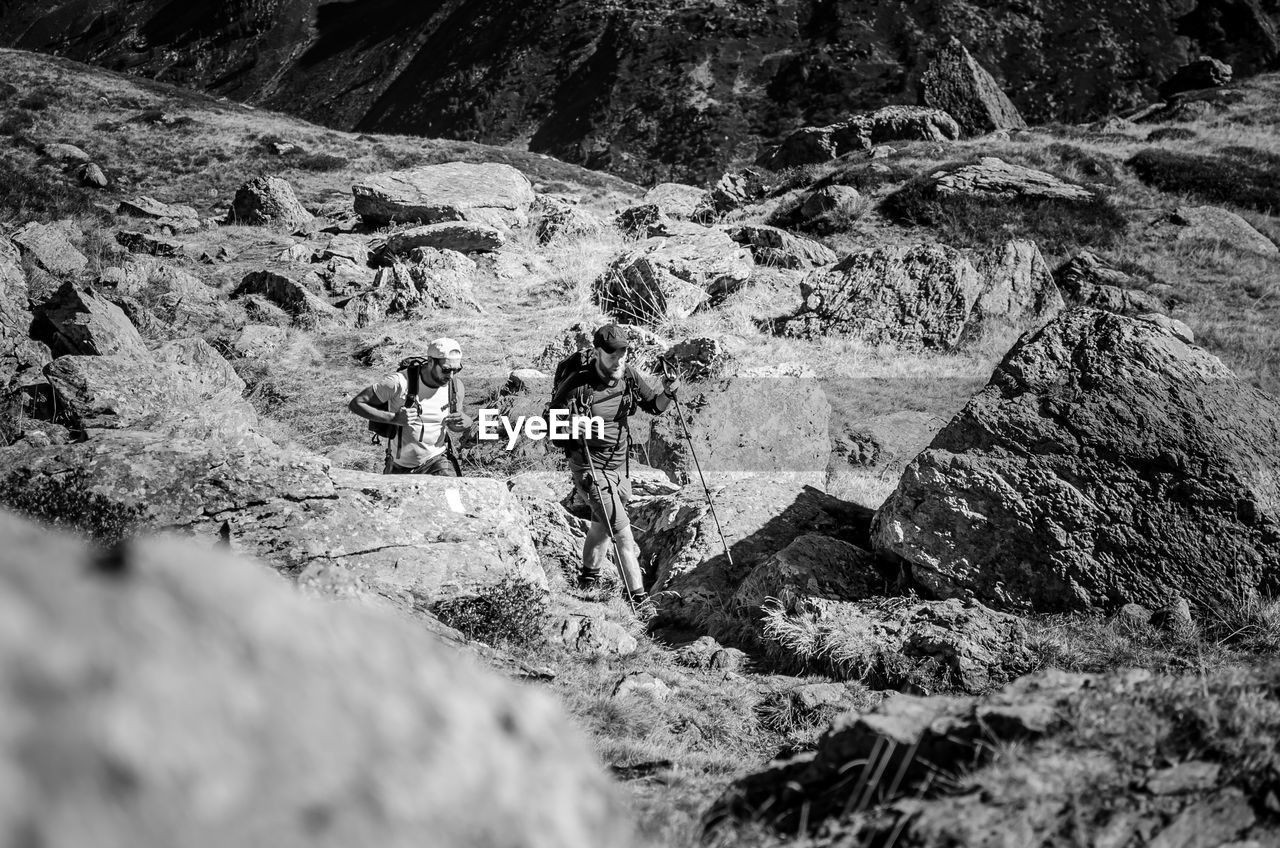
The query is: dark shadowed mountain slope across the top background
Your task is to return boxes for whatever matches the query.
[0,0,1280,183]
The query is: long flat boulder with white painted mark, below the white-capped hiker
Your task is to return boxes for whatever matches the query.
[0,430,547,610]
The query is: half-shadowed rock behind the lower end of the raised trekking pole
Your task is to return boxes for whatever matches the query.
[630,479,870,635]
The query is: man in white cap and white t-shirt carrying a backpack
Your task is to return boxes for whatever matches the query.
[347,338,471,477]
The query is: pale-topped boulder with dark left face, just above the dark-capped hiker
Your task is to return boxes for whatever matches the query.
[593,228,755,324]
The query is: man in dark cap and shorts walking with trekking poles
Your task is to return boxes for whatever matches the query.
[549,324,680,606]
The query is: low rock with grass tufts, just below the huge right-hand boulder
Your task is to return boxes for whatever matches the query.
[759,594,1036,693]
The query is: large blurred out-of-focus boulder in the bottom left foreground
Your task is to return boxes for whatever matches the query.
[0,514,631,848]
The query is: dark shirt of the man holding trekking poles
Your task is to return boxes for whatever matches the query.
[550,359,671,470]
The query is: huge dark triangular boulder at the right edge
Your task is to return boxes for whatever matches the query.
[874,309,1280,610]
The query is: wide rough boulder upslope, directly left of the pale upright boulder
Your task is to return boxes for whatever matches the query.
[787,245,984,350]
